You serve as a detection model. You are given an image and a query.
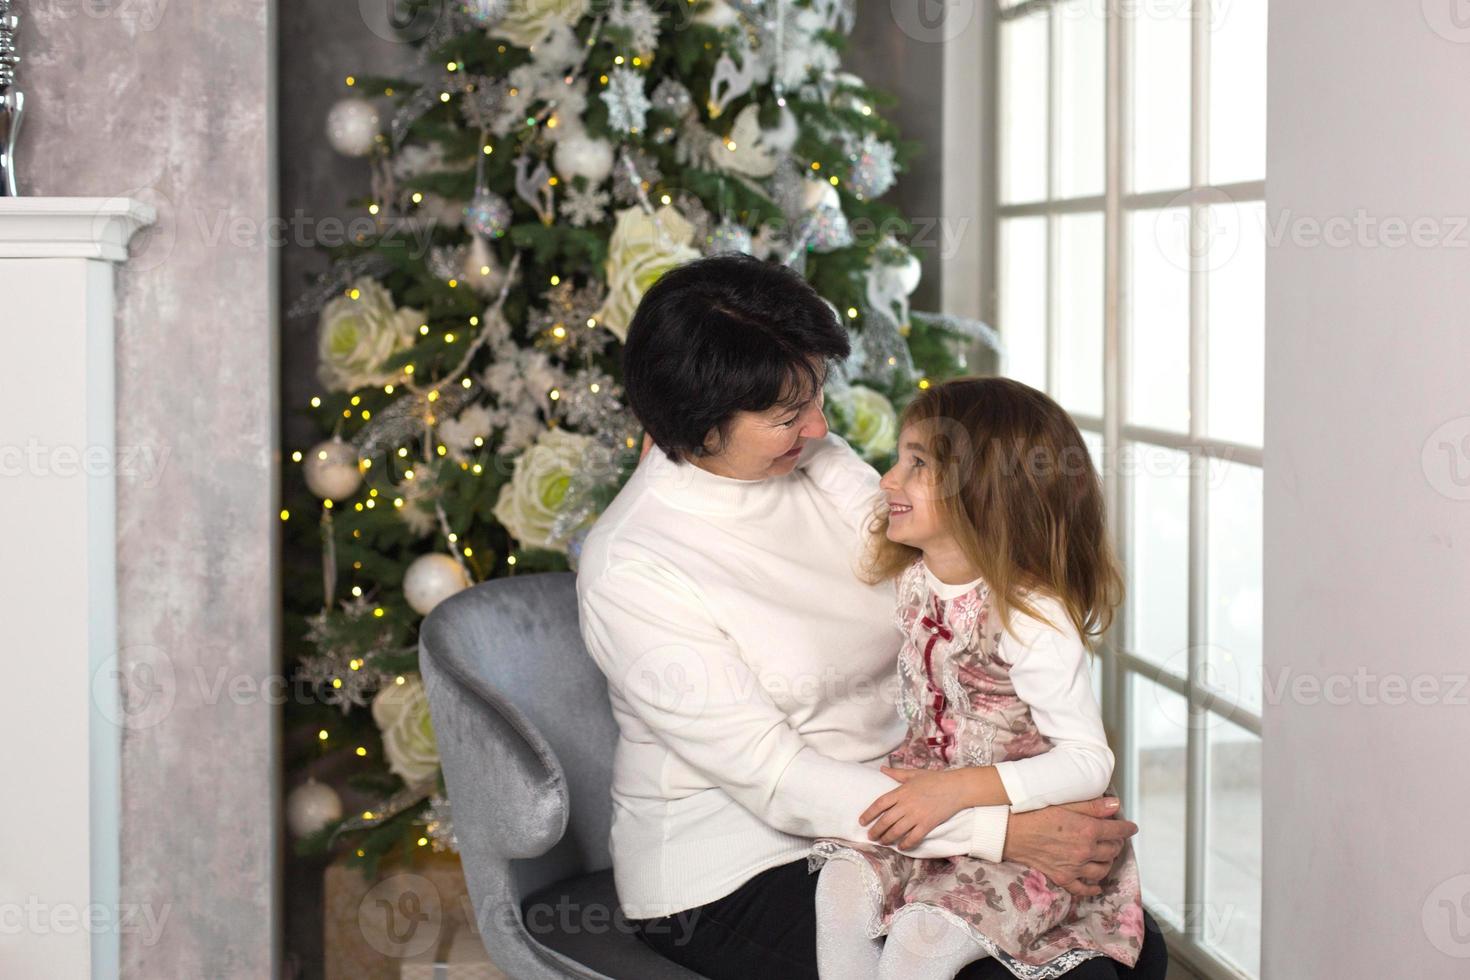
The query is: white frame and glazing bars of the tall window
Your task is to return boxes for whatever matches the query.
[944,0,1266,980]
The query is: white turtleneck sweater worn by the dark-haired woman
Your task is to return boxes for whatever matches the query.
[576,433,1008,918]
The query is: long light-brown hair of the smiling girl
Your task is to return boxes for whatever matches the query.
[864,378,1123,644]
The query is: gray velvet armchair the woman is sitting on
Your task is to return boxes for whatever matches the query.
[419,572,700,980]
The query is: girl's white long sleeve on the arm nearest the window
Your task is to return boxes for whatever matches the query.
[995,599,1113,813]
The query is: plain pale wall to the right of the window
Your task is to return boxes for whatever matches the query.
[1264,0,1470,980]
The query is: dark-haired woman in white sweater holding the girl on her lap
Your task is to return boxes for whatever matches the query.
[578,256,1166,980]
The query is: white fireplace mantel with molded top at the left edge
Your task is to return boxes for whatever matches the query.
[0,197,154,977]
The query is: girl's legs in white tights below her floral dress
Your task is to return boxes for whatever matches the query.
[816,861,986,980]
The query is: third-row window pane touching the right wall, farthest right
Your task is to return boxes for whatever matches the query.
[1202,460,1263,714]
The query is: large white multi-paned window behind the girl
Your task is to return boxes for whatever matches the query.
[989,0,1266,977]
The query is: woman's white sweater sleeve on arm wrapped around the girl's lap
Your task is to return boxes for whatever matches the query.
[581,558,1008,861]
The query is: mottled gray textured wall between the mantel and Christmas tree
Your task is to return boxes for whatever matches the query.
[18,0,279,977]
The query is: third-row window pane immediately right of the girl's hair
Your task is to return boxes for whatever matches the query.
[1120,442,1189,677]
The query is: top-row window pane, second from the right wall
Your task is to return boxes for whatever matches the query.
[1125,0,1191,191]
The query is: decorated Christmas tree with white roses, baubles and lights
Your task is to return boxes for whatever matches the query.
[284,0,991,864]
